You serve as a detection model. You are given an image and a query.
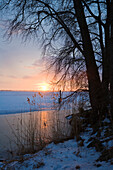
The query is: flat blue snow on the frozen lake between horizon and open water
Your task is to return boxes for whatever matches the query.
[0,91,90,115]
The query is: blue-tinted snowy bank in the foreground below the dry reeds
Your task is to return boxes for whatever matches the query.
[1,135,113,170]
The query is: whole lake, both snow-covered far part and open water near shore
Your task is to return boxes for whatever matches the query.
[0,91,89,159]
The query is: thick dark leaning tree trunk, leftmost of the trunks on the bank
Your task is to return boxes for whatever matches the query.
[73,0,103,115]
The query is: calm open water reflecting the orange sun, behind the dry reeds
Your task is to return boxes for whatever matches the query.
[0,110,71,159]
